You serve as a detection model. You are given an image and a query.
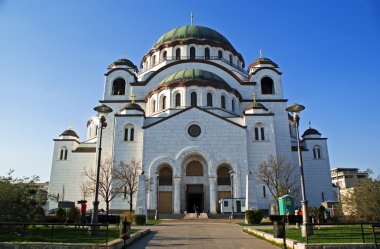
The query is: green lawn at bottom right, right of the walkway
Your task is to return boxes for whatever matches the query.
[259,225,374,243]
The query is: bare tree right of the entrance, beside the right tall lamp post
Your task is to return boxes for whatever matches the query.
[254,154,298,208]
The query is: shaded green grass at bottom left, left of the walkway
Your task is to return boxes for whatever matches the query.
[0,226,137,244]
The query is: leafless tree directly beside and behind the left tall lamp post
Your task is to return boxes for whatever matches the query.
[84,160,122,214]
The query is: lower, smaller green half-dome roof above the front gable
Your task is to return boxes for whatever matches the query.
[160,69,229,87]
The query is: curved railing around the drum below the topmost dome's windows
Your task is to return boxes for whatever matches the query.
[141,56,247,74]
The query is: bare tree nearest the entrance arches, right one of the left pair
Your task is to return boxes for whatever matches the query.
[114,160,141,211]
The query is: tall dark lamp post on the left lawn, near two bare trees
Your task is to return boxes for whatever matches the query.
[91,104,112,235]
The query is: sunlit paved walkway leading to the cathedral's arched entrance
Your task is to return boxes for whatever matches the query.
[128,220,278,249]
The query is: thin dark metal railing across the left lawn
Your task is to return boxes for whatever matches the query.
[0,222,109,244]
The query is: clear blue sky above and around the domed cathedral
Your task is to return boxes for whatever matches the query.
[0,0,380,181]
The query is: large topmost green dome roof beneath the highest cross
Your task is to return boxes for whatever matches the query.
[152,25,235,51]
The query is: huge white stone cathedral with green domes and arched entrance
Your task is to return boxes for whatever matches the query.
[49,25,333,214]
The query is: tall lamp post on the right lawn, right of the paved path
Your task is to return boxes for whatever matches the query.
[286,103,311,237]
